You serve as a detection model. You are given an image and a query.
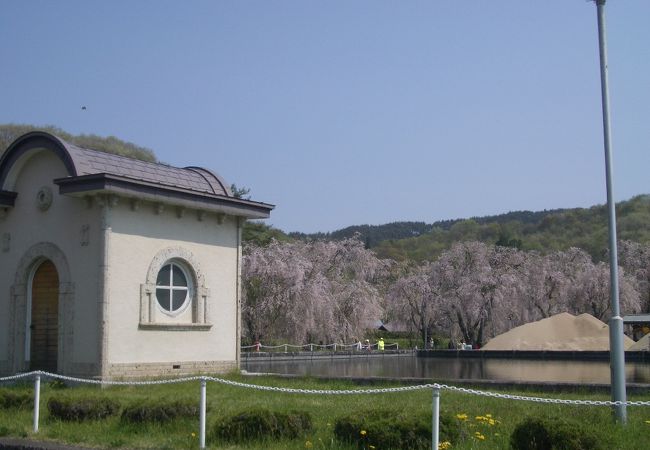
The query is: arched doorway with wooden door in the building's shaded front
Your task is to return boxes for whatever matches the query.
[29,260,59,373]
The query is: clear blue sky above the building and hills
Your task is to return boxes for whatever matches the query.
[0,0,650,232]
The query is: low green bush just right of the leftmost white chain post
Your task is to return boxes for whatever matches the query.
[47,396,120,422]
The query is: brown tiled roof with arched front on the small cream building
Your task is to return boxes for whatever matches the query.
[0,131,274,218]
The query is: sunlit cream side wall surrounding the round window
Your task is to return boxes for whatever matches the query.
[106,199,238,366]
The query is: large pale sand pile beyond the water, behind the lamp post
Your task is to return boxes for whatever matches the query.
[483,313,634,350]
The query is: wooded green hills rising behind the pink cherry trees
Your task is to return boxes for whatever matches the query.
[289,195,650,261]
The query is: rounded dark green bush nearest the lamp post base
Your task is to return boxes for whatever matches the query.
[510,417,611,450]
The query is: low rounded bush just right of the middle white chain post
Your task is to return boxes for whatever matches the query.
[213,409,312,442]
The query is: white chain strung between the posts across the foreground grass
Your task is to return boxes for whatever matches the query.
[0,370,650,406]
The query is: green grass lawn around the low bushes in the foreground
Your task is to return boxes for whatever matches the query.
[0,375,650,450]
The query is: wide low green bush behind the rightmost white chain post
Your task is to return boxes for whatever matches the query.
[334,410,461,449]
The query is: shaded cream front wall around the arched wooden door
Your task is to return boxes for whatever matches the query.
[0,151,99,374]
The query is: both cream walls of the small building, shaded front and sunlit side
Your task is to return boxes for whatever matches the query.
[0,151,239,376]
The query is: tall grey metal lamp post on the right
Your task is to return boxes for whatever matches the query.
[594,0,627,424]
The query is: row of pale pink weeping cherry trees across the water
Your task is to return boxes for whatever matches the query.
[242,238,650,345]
